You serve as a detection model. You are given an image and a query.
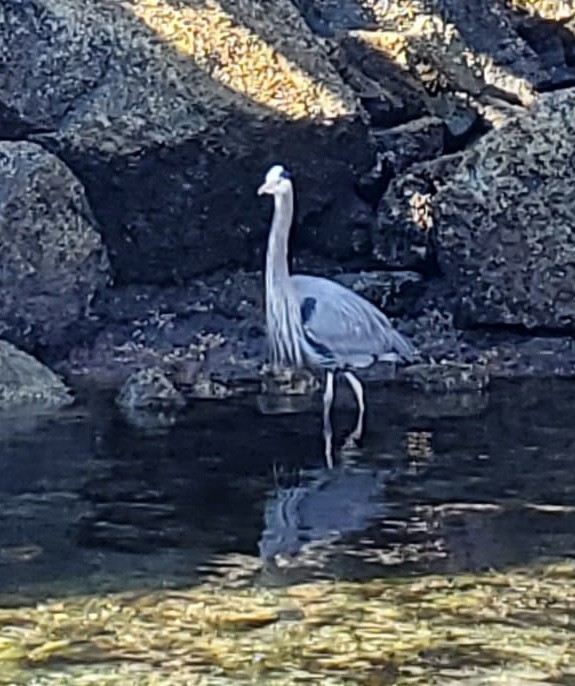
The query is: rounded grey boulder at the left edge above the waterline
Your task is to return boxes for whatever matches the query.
[0,141,108,351]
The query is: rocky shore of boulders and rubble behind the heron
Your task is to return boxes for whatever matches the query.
[0,0,575,404]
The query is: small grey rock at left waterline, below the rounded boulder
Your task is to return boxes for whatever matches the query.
[0,340,73,410]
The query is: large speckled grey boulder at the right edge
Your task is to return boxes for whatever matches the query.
[379,89,575,332]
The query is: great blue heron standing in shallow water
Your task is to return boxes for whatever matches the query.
[258,164,416,460]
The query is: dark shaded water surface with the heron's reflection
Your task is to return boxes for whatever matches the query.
[0,381,575,602]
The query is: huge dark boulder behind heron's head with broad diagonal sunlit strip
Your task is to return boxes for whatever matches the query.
[0,0,372,283]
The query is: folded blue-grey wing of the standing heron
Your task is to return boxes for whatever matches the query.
[291,274,415,367]
